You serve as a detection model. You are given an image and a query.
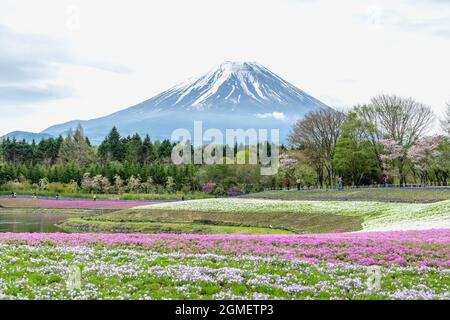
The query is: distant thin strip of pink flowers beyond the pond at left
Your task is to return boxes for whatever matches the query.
[33,199,154,209]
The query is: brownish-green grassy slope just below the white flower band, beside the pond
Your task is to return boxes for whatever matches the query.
[61,210,363,234]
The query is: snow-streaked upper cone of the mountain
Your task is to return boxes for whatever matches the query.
[142,61,323,110]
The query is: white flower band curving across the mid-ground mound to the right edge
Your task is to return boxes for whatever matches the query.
[133,198,450,231]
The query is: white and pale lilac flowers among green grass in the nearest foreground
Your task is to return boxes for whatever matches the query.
[0,243,450,299]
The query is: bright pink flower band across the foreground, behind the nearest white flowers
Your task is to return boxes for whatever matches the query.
[0,229,450,268]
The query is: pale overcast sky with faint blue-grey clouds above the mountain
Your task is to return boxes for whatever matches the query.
[0,0,450,135]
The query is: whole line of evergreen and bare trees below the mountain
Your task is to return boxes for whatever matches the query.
[0,95,450,195]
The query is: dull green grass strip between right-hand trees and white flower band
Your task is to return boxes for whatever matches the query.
[244,188,450,203]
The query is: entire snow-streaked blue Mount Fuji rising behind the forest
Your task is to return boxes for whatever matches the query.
[42,62,329,143]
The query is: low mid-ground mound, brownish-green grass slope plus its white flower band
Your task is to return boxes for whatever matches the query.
[58,198,450,234]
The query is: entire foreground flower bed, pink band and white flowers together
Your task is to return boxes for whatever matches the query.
[0,229,450,299]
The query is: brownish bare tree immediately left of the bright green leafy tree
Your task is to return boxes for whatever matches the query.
[289,109,346,186]
